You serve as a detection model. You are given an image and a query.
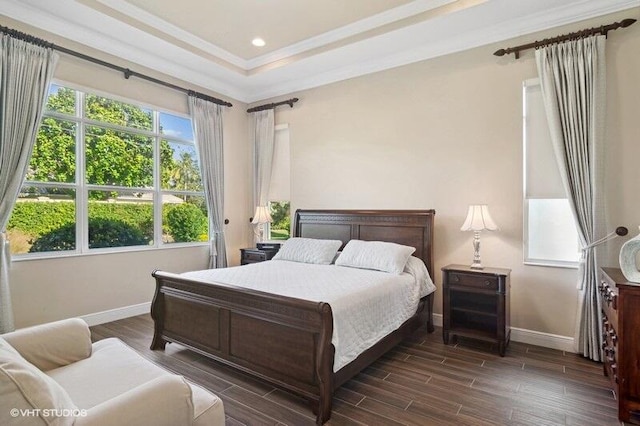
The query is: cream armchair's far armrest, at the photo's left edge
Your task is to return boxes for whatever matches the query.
[0,318,91,371]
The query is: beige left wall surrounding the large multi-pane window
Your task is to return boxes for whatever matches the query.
[0,17,252,327]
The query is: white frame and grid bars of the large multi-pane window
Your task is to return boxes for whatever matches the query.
[11,79,210,261]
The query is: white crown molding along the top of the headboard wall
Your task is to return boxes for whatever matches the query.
[241,0,640,102]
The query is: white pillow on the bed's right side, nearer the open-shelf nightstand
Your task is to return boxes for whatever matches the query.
[336,240,416,275]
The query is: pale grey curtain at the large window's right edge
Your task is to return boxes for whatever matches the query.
[189,96,227,268]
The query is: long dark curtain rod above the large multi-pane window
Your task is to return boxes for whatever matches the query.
[0,25,233,107]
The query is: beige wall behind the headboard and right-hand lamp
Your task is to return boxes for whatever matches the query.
[266,9,640,337]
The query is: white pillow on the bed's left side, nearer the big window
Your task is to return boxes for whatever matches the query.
[273,238,342,265]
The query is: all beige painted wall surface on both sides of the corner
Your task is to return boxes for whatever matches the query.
[2,9,640,336]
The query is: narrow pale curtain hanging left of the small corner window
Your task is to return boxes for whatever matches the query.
[252,109,275,236]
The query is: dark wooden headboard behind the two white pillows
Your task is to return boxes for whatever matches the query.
[293,210,436,277]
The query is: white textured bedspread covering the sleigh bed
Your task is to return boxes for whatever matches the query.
[182,260,435,371]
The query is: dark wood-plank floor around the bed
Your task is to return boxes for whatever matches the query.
[91,315,620,426]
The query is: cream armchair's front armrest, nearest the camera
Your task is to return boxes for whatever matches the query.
[74,374,193,426]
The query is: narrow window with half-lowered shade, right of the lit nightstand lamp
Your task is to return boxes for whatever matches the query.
[523,79,580,267]
